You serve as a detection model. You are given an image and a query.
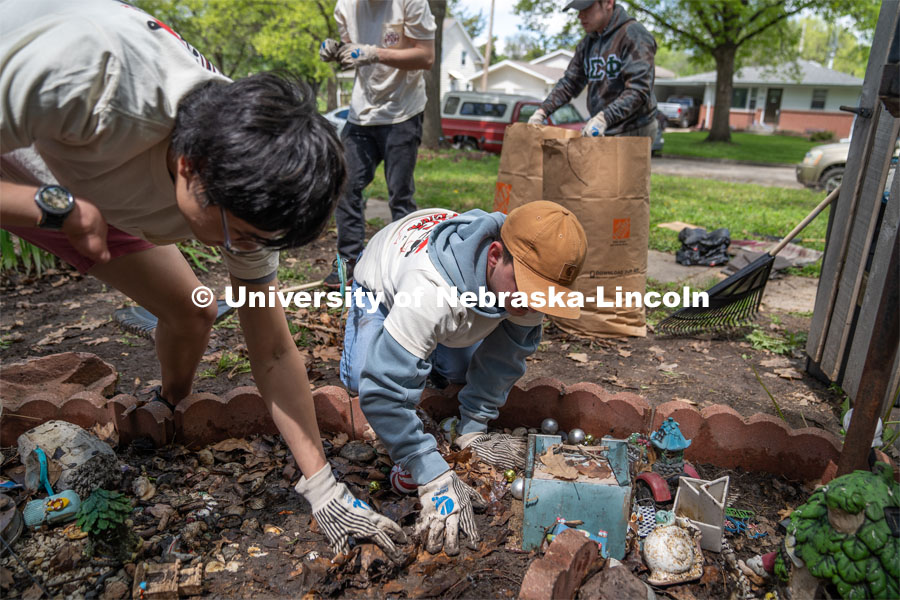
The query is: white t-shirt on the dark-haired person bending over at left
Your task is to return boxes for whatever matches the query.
[0,0,278,279]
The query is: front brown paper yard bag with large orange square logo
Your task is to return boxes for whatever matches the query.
[540,137,650,337]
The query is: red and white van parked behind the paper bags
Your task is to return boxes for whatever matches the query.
[441,92,585,154]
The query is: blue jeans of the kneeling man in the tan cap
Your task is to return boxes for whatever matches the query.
[340,282,481,394]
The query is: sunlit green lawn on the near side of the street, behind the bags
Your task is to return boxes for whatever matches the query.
[366,149,828,276]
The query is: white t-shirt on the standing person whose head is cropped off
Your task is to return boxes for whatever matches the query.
[334,0,437,125]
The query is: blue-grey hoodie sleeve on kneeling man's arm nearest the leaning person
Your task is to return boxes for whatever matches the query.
[359,329,450,484]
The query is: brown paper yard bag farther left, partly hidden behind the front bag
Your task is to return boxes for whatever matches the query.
[494,123,580,214]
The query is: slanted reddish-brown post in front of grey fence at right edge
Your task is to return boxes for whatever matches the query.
[837,235,900,476]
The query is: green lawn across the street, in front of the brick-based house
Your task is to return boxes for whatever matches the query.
[663,131,822,164]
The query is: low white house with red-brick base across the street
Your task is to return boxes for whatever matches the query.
[656,60,863,138]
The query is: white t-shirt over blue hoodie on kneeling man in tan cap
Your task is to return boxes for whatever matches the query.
[353,208,543,360]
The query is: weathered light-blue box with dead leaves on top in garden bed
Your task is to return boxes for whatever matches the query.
[522,435,631,559]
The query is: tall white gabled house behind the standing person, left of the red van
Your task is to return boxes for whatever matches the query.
[338,17,484,106]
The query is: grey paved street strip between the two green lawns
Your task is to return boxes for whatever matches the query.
[650,156,803,189]
